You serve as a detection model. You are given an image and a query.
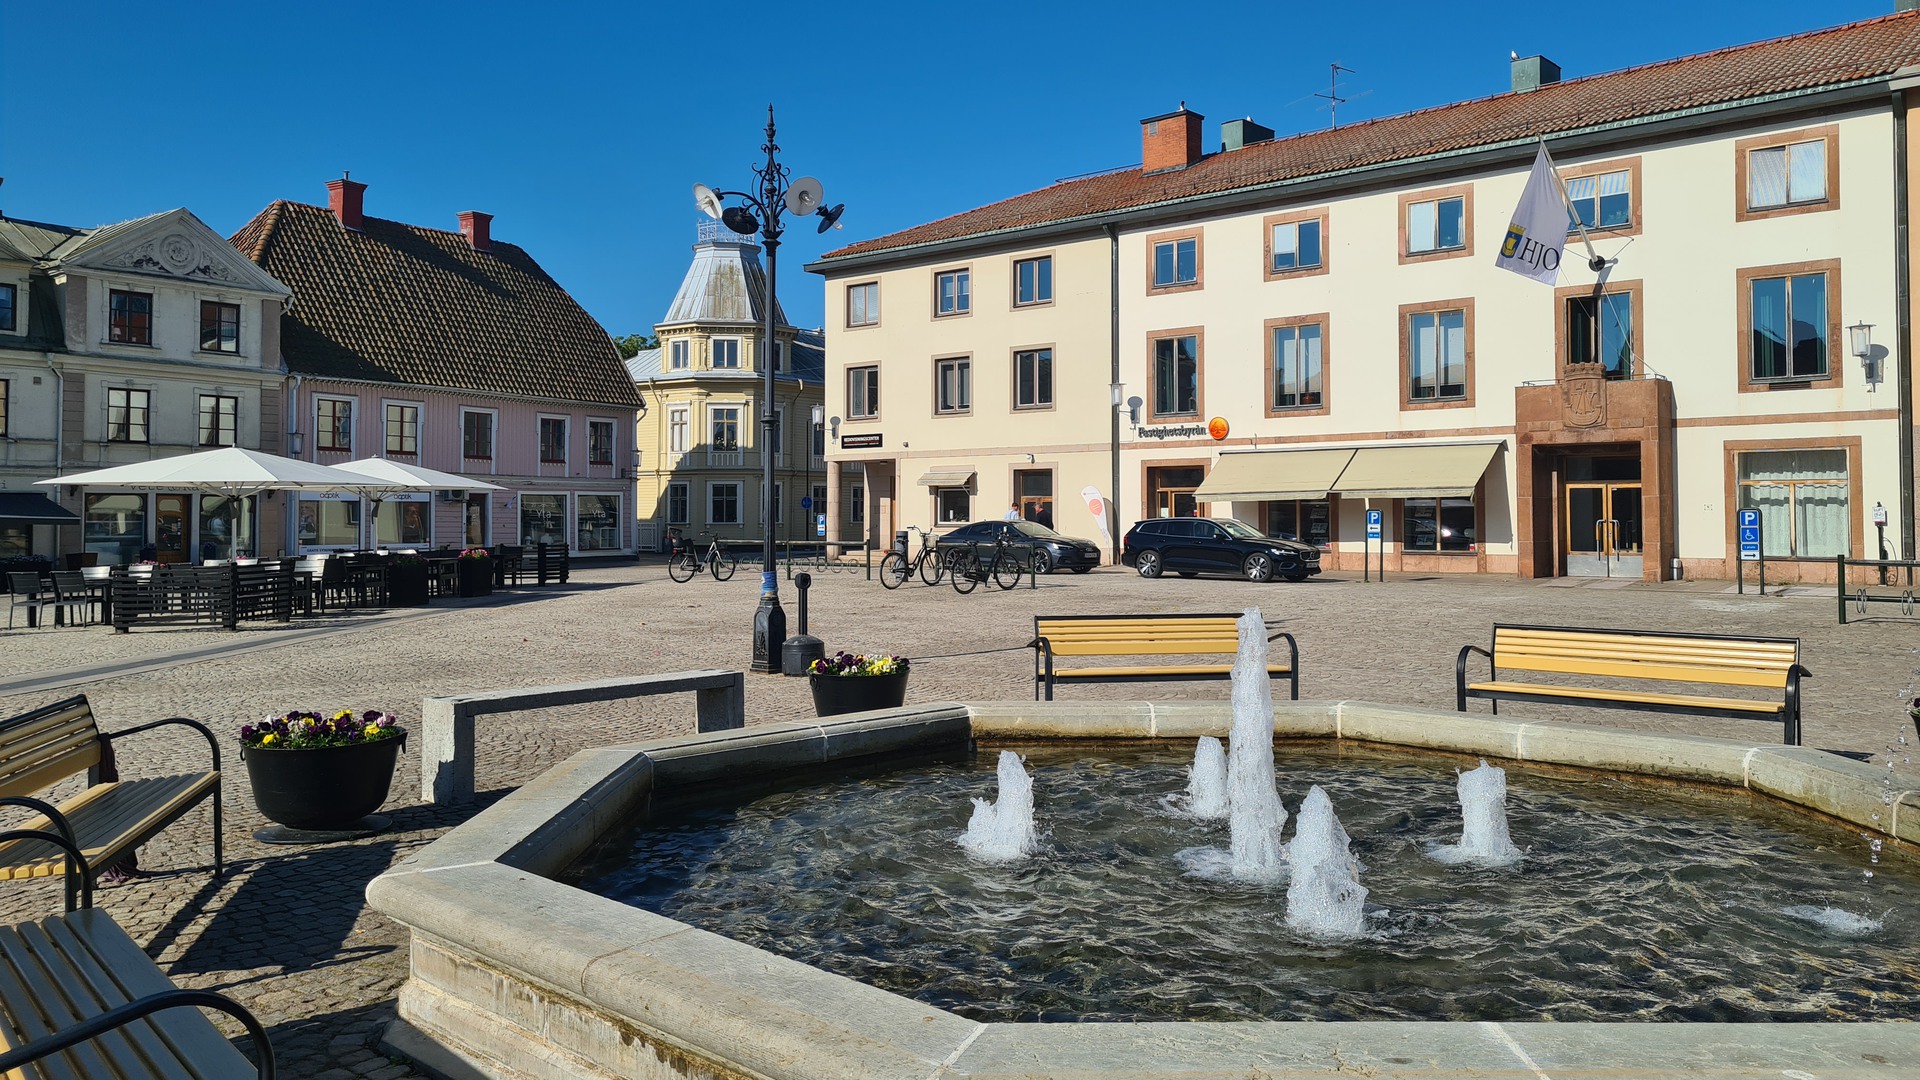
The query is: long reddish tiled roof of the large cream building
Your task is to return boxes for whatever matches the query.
[822,12,1920,261]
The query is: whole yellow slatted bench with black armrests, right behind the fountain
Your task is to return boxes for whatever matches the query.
[1453,625,1812,746]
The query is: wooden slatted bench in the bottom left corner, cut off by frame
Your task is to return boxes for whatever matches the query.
[0,830,275,1080]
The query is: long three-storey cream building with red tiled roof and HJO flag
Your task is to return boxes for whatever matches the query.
[808,12,1920,580]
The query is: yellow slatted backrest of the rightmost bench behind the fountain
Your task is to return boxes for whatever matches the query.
[1494,625,1799,686]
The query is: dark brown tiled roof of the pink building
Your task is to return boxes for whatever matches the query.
[232,200,639,407]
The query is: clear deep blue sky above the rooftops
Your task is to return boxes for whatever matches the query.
[0,0,1893,334]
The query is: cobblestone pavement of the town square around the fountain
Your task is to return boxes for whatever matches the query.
[0,563,1920,1080]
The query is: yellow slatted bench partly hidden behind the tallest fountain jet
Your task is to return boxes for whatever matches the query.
[1027,615,1300,701]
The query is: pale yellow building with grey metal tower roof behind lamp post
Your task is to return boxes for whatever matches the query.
[628,221,837,553]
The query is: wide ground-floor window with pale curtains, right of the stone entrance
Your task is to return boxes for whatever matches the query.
[1740,450,1853,559]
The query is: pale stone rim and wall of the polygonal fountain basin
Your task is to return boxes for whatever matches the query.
[367,701,1920,1080]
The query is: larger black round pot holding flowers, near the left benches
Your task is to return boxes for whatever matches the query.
[240,732,407,832]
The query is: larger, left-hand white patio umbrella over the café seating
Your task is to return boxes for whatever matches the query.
[35,446,401,557]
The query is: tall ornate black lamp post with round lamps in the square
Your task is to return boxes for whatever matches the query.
[693,106,845,675]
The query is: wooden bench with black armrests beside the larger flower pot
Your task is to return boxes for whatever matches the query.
[0,694,225,878]
